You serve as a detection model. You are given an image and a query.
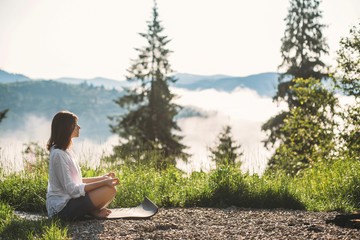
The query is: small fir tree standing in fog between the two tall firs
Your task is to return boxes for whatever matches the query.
[209,126,243,167]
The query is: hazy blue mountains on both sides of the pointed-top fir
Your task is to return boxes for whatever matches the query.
[0,70,278,140]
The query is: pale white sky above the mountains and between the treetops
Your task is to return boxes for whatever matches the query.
[0,0,360,80]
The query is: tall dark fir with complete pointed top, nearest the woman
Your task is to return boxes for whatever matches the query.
[109,1,188,167]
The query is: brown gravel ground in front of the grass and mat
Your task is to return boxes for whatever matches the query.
[68,207,360,239]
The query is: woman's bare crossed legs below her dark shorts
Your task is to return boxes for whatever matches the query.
[89,186,116,217]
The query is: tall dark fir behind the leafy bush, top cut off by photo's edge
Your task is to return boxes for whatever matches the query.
[262,0,328,146]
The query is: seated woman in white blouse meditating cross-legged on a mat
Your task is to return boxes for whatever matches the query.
[46,111,119,220]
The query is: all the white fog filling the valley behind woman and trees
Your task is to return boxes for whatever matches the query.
[5,88,354,174]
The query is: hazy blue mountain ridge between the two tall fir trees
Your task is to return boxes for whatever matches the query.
[174,72,279,97]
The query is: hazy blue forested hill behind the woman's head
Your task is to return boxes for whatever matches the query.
[0,81,122,138]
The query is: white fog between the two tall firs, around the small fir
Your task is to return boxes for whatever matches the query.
[172,88,286,174]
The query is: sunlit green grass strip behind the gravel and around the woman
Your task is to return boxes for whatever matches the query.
[0,149,360,239]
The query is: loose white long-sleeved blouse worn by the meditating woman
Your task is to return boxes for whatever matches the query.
[46,147,85,218]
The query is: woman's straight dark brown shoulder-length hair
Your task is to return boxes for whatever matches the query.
[47,111,78,151]
